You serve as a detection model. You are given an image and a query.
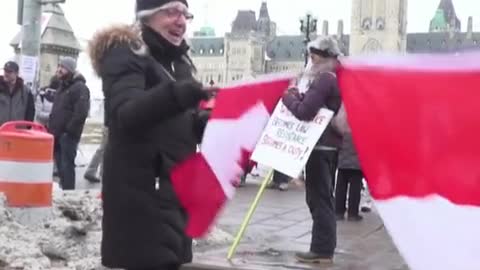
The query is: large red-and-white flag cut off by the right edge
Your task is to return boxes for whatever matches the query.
[338,53,480,270]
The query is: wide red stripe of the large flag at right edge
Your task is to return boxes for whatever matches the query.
[338,67,480,206]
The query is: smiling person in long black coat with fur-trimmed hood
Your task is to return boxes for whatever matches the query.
[89,0,210,270]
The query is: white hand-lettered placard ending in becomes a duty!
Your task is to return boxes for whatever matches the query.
[252,102,334,177]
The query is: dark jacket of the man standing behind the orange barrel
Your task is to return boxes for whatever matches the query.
[0,76,35,125]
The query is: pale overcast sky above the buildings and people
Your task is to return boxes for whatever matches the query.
[0,0,480,96]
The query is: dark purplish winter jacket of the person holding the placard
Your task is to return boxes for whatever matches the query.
[283,72,342,148]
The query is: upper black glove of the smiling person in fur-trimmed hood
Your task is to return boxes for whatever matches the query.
[173,80,210,109]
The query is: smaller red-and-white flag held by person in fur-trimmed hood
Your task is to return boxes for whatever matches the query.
[171,75,293,238]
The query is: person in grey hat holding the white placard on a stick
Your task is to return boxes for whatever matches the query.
[283,36,342,263]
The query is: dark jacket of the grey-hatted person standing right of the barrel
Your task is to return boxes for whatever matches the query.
[48,73,90,141]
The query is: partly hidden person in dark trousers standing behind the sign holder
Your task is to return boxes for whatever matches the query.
[335,106,363,221]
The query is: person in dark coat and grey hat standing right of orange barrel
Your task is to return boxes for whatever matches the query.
[48,57,90,190]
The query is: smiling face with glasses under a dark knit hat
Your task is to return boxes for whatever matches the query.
[146,2,193,46]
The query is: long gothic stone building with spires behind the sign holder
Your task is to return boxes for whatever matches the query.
[190,0,480,85]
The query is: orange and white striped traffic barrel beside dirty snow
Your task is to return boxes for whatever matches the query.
[0,121,53,208]
